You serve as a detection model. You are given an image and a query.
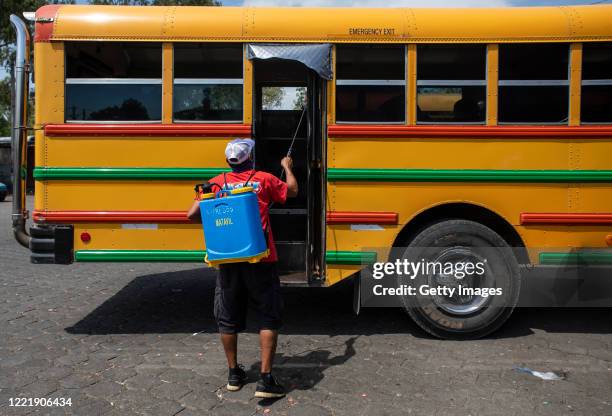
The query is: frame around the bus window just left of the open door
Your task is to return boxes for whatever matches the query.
[172,42,247,124]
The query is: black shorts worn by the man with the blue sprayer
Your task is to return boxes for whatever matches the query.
[214,262,283,334]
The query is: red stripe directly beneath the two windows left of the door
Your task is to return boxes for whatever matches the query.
[45,124,251,137]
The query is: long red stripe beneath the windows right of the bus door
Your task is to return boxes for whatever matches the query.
[328,124,612,138]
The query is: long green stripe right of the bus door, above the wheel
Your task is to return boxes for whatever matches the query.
[327,168,612,182]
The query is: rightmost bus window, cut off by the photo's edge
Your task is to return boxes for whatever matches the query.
[580,43,612,123]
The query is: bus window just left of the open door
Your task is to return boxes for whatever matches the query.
[173,43,243,122]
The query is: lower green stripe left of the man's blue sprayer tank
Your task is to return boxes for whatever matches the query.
[74,250,206,263]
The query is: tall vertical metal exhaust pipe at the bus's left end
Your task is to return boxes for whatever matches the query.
[10,14,30,247]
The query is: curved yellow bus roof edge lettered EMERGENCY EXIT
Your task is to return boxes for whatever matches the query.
[35,5,612,43]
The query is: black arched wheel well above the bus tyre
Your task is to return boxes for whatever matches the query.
[393,203,529,264]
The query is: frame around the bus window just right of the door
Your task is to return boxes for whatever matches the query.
[332,43,409,126]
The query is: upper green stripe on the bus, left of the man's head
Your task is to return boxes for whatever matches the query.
[34,167,230,181]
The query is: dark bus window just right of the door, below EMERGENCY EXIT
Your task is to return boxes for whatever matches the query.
[336,45,406,123]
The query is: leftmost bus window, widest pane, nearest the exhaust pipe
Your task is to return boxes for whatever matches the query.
[65,42,162,122]
